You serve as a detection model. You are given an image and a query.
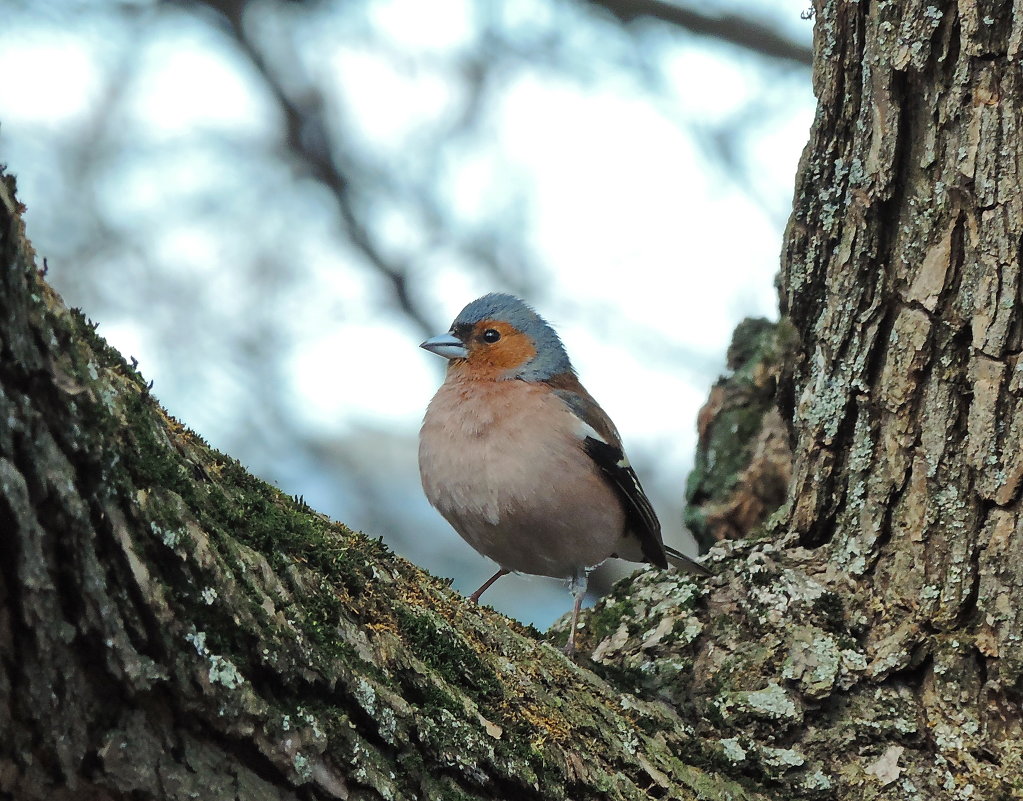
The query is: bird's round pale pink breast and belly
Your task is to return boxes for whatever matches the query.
[419,382,624,577]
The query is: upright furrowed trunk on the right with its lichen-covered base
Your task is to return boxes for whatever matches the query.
[576,1,1023,799]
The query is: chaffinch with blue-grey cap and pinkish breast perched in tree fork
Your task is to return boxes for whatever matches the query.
[418,293,710,654]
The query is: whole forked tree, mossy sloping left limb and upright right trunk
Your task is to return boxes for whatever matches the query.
[0,0,1023,801]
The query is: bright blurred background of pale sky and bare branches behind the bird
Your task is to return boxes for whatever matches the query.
[0,0,813,625]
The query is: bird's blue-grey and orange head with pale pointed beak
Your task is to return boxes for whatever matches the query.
[419,293,572,381]
